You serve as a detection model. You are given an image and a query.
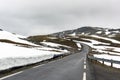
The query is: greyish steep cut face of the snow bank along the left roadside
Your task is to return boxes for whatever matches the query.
[0,54,53,70]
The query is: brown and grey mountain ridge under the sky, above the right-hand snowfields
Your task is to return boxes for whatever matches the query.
[27,26,120,48]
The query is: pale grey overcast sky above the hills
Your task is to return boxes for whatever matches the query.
[0,0,120,36]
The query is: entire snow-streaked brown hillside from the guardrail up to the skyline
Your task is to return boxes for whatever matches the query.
[28,26,120,68]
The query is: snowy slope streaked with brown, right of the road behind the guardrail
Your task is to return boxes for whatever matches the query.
[75,35,120,68]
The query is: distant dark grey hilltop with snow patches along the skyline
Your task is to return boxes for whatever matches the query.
[51,26,120,40]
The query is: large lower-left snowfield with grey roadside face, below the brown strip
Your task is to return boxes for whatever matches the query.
[0,42,65,70]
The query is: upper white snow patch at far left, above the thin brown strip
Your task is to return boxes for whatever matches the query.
[0,31,38,46]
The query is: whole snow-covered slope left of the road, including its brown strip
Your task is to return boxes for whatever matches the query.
[0,30,69,70]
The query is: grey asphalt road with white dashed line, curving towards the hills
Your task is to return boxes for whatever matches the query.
[0,44,90,80]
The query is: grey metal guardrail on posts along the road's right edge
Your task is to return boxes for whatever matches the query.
[87,55,120,67]
